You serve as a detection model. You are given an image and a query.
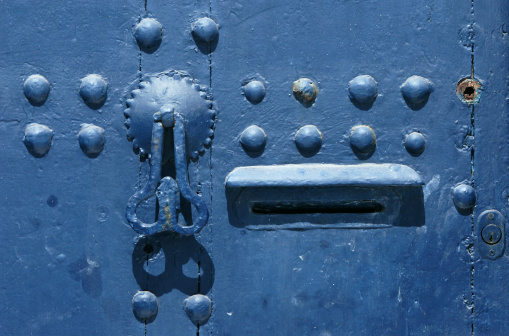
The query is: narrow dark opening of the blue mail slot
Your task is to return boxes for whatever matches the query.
[251,200,385,215]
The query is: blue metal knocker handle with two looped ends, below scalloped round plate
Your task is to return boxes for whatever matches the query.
[126,108,209,235]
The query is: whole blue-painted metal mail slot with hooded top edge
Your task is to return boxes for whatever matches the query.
[225,164,425,230]
